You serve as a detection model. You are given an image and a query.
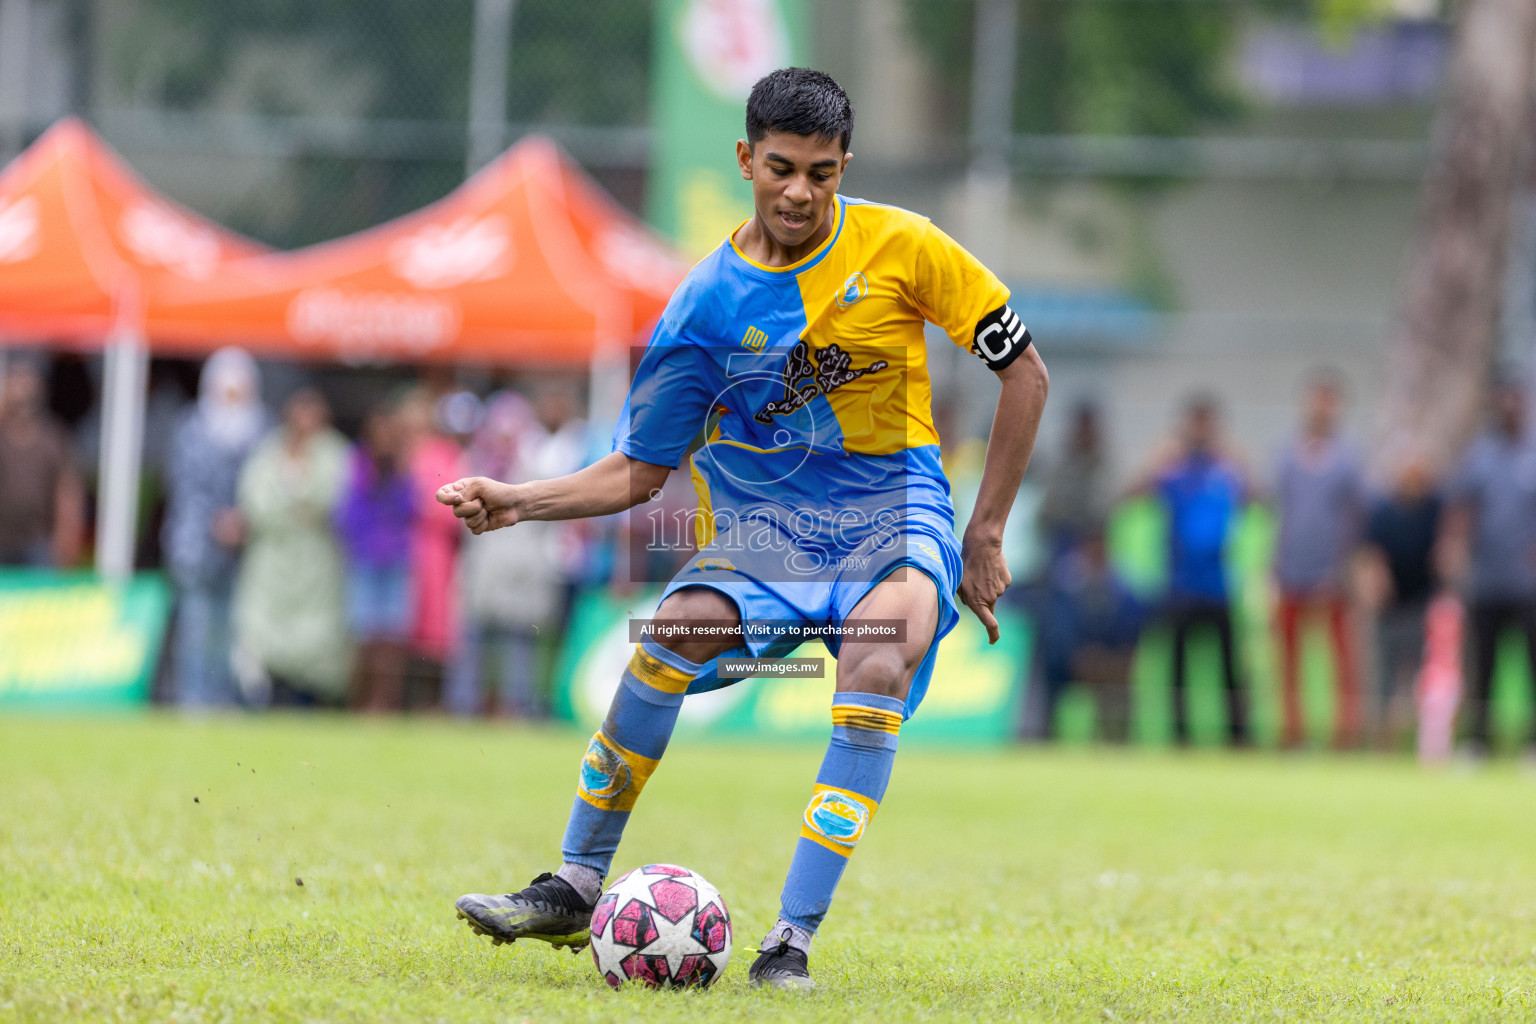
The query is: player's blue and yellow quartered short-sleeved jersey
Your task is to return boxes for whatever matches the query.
[613,197,1021,550]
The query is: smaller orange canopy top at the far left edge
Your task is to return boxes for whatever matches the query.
[0,118,266,345]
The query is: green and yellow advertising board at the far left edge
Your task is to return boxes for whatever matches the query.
[0,570,170,711]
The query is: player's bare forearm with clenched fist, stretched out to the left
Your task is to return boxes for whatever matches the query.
[438,451,671,534]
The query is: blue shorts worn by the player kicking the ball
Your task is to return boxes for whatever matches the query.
[662,513,960,718]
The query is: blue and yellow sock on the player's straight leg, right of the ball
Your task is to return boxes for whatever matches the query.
[763,694,906,949]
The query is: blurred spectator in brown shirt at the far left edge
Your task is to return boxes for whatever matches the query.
[0,356,84,568]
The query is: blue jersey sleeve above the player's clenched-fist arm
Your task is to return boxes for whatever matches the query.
[613,316,716,468]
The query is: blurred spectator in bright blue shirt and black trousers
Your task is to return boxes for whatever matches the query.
[1132,396,1253,746]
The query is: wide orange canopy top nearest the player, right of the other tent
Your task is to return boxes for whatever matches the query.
[146,137,687,368]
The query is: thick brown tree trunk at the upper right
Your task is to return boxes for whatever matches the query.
[1376,0,1536,473]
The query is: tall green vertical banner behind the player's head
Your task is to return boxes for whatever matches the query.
[647,0,806,258]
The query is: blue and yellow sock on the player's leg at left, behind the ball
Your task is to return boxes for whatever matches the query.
[561,639,702,895]
